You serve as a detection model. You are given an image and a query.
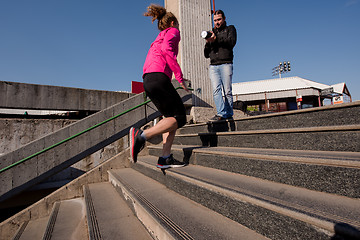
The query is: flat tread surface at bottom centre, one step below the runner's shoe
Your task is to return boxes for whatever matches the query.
[110,168,267,239]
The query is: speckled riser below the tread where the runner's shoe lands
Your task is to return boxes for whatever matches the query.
[134,164,330,239]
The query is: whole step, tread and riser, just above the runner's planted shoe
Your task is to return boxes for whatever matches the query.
[148,145,360,198]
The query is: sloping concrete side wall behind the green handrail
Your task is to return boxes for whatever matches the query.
[0,94,159,201]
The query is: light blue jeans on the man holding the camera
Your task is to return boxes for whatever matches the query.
[209,63,233,118]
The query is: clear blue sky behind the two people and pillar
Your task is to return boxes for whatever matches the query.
[0,0,360,100]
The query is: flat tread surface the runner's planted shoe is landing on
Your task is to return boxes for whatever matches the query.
[138,156,360,227]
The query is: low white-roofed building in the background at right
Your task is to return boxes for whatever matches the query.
[232,77,352,112]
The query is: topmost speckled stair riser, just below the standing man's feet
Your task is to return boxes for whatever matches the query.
[179,104,360,134]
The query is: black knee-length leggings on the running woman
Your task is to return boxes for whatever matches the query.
[144,72,186,128]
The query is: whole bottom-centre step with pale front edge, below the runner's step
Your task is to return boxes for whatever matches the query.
[109,168,267,239]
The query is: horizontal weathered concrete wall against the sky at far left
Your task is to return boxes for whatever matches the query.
[0,81,134,111]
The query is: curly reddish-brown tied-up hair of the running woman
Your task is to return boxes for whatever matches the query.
[144,4,178,31]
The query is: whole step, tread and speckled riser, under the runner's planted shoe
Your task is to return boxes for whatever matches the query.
[133,156,360,239]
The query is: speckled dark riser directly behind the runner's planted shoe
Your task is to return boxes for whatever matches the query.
[149,148,360,198]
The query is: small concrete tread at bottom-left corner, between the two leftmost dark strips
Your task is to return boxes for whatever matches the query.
[13,217,49,240]
